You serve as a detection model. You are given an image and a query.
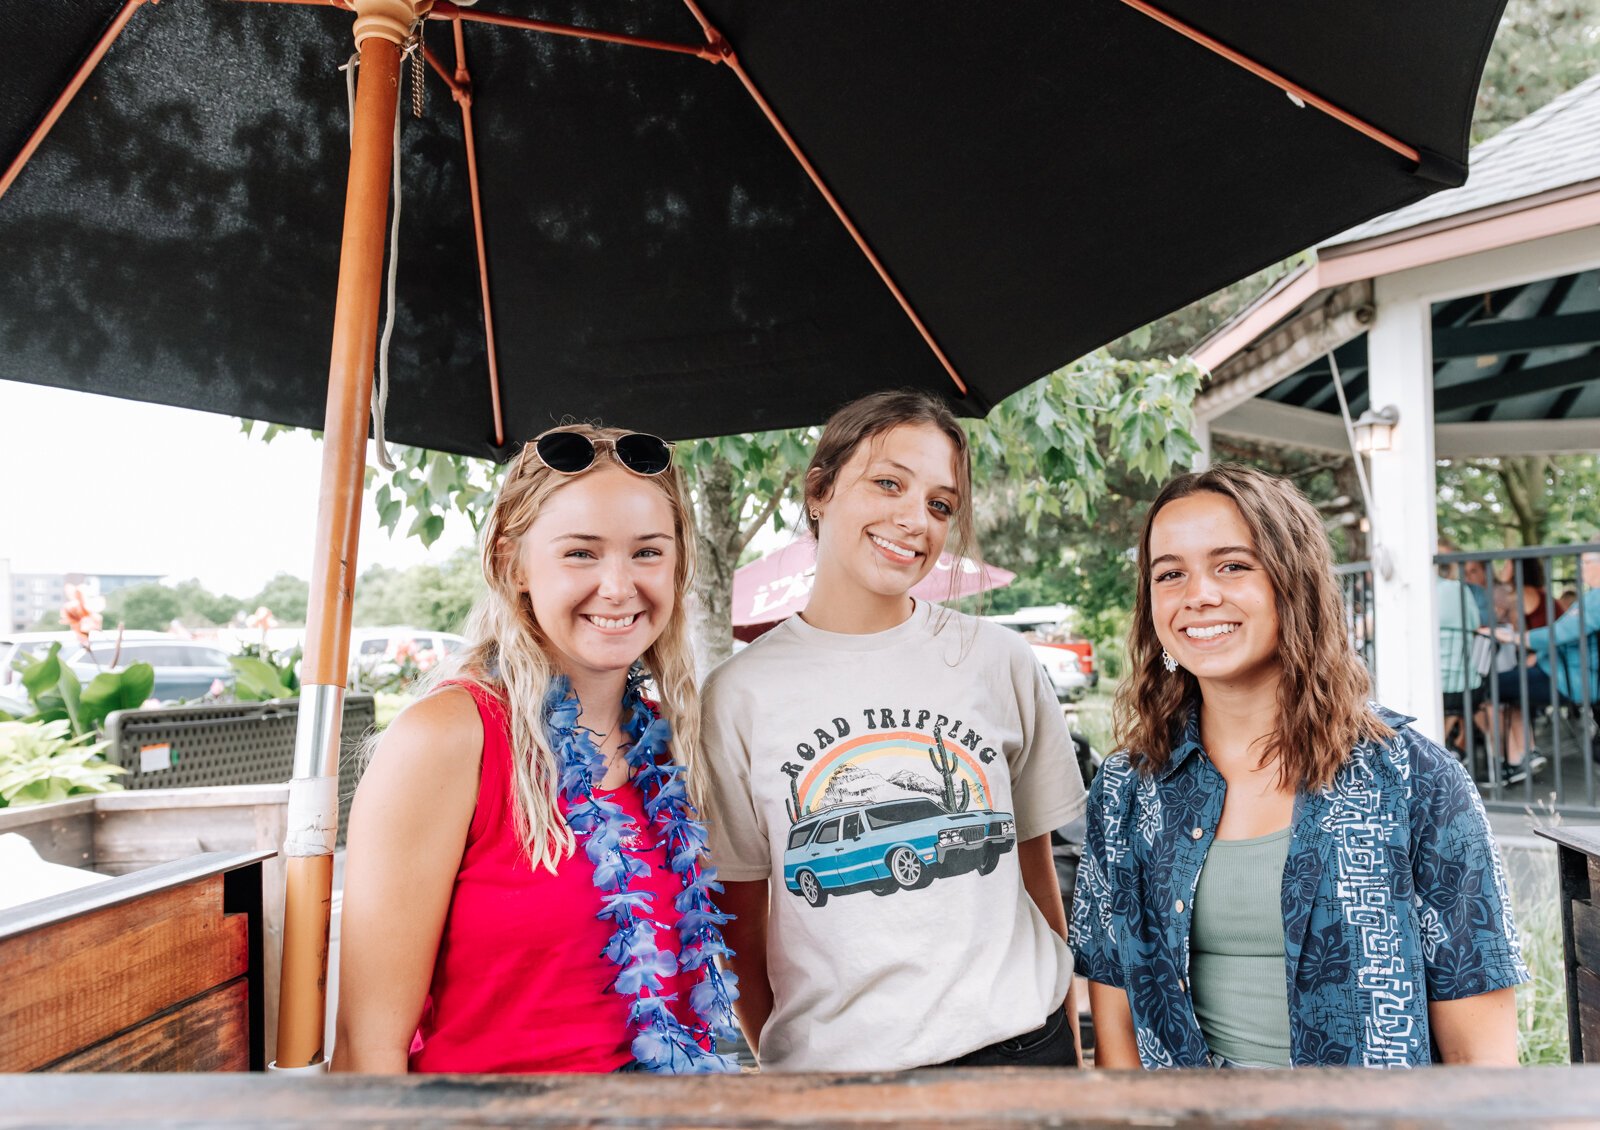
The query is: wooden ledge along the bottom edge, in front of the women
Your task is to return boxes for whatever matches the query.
[0,1066,1600,1130]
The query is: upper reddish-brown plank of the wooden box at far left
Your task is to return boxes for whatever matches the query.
[0,874,250,1071]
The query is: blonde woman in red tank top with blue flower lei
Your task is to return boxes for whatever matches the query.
[333,427,738,1072]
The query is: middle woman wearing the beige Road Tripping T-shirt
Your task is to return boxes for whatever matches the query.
[702,392,1083,1071]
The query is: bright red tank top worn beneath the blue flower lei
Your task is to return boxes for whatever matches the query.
[411,683,698,1072]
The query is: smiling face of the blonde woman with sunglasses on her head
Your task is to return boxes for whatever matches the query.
[515,464,678,682]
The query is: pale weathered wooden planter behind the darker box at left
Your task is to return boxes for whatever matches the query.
[0,784,290,1071]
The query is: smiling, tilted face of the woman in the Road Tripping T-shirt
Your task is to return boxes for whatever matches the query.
[808,424,962,613]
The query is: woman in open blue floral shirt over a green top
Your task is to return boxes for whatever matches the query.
[1072,466,1528,1068]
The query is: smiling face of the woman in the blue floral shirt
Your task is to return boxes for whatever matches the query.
[1147,491,1278,690]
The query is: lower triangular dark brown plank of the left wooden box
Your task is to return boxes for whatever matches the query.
[43,978,250,1071]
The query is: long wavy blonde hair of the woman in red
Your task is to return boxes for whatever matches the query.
[430,424,699,872]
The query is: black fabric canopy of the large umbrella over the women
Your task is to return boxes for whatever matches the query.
[0,0,1504,456]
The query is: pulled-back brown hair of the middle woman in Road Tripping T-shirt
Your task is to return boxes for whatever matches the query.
[803,389,982,592]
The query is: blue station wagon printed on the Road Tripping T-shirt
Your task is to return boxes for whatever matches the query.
[784,797,1016,906]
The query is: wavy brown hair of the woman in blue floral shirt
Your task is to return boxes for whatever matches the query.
[1114,463,1394,791]
